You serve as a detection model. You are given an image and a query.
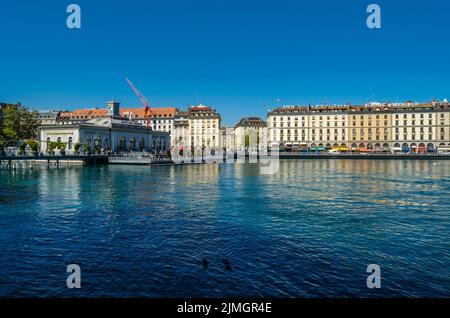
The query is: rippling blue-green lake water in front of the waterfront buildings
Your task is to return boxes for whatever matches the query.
[0,160,450,297]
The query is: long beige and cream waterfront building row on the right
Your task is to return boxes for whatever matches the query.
[268,100,450,153]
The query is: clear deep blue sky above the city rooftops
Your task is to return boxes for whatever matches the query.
[0,0,450,124]
